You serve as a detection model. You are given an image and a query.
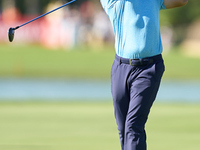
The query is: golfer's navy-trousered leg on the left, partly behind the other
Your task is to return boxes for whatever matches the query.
[111,56,131,150]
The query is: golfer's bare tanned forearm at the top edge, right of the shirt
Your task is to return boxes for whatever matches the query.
[163,0,188,9]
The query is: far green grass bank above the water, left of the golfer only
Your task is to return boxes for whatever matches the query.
[0,45,114,78]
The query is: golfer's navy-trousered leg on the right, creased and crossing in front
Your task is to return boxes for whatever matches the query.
[124,60,164,150]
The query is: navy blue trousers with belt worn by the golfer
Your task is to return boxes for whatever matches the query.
[111,54,165,150]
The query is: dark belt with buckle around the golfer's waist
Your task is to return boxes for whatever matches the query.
[115,54,162,66]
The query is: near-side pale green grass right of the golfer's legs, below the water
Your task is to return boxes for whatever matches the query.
[147,104,200,150]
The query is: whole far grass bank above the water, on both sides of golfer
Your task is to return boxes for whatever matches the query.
[0,44,200,79]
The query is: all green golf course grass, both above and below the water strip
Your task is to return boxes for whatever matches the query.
[0,44,200,150]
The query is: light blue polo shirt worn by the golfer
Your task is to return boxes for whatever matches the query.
[101,0,166,59]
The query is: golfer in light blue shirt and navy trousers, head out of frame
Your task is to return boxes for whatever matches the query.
[101,0,187,150]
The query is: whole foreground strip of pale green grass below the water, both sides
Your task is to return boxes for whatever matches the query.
[0,102,200,150]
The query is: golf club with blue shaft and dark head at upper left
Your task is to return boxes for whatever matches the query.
[8,0,76,42]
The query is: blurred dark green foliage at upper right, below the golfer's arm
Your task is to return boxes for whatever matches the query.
[160,0,200,45]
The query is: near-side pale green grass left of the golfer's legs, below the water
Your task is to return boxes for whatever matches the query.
[0,102,119,150]
